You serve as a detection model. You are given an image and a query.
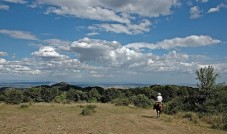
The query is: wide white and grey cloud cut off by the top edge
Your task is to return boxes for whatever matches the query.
[36,0,179,20]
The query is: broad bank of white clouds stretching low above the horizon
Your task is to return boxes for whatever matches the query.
[0,35,226,80]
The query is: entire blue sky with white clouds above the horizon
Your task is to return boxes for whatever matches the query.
[0,0,227,84]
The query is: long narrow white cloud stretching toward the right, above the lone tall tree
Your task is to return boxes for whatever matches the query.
[126,35,221,50]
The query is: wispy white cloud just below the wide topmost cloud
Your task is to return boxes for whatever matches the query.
[90,20,151,35]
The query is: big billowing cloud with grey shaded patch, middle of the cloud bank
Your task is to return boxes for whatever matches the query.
[70,38,142,67]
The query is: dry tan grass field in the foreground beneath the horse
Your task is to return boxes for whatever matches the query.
[0,103,226,134]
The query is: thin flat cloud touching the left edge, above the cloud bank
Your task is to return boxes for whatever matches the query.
[0,29,38,40]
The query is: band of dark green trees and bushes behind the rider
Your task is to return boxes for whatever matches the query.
[0,66,227,130]
